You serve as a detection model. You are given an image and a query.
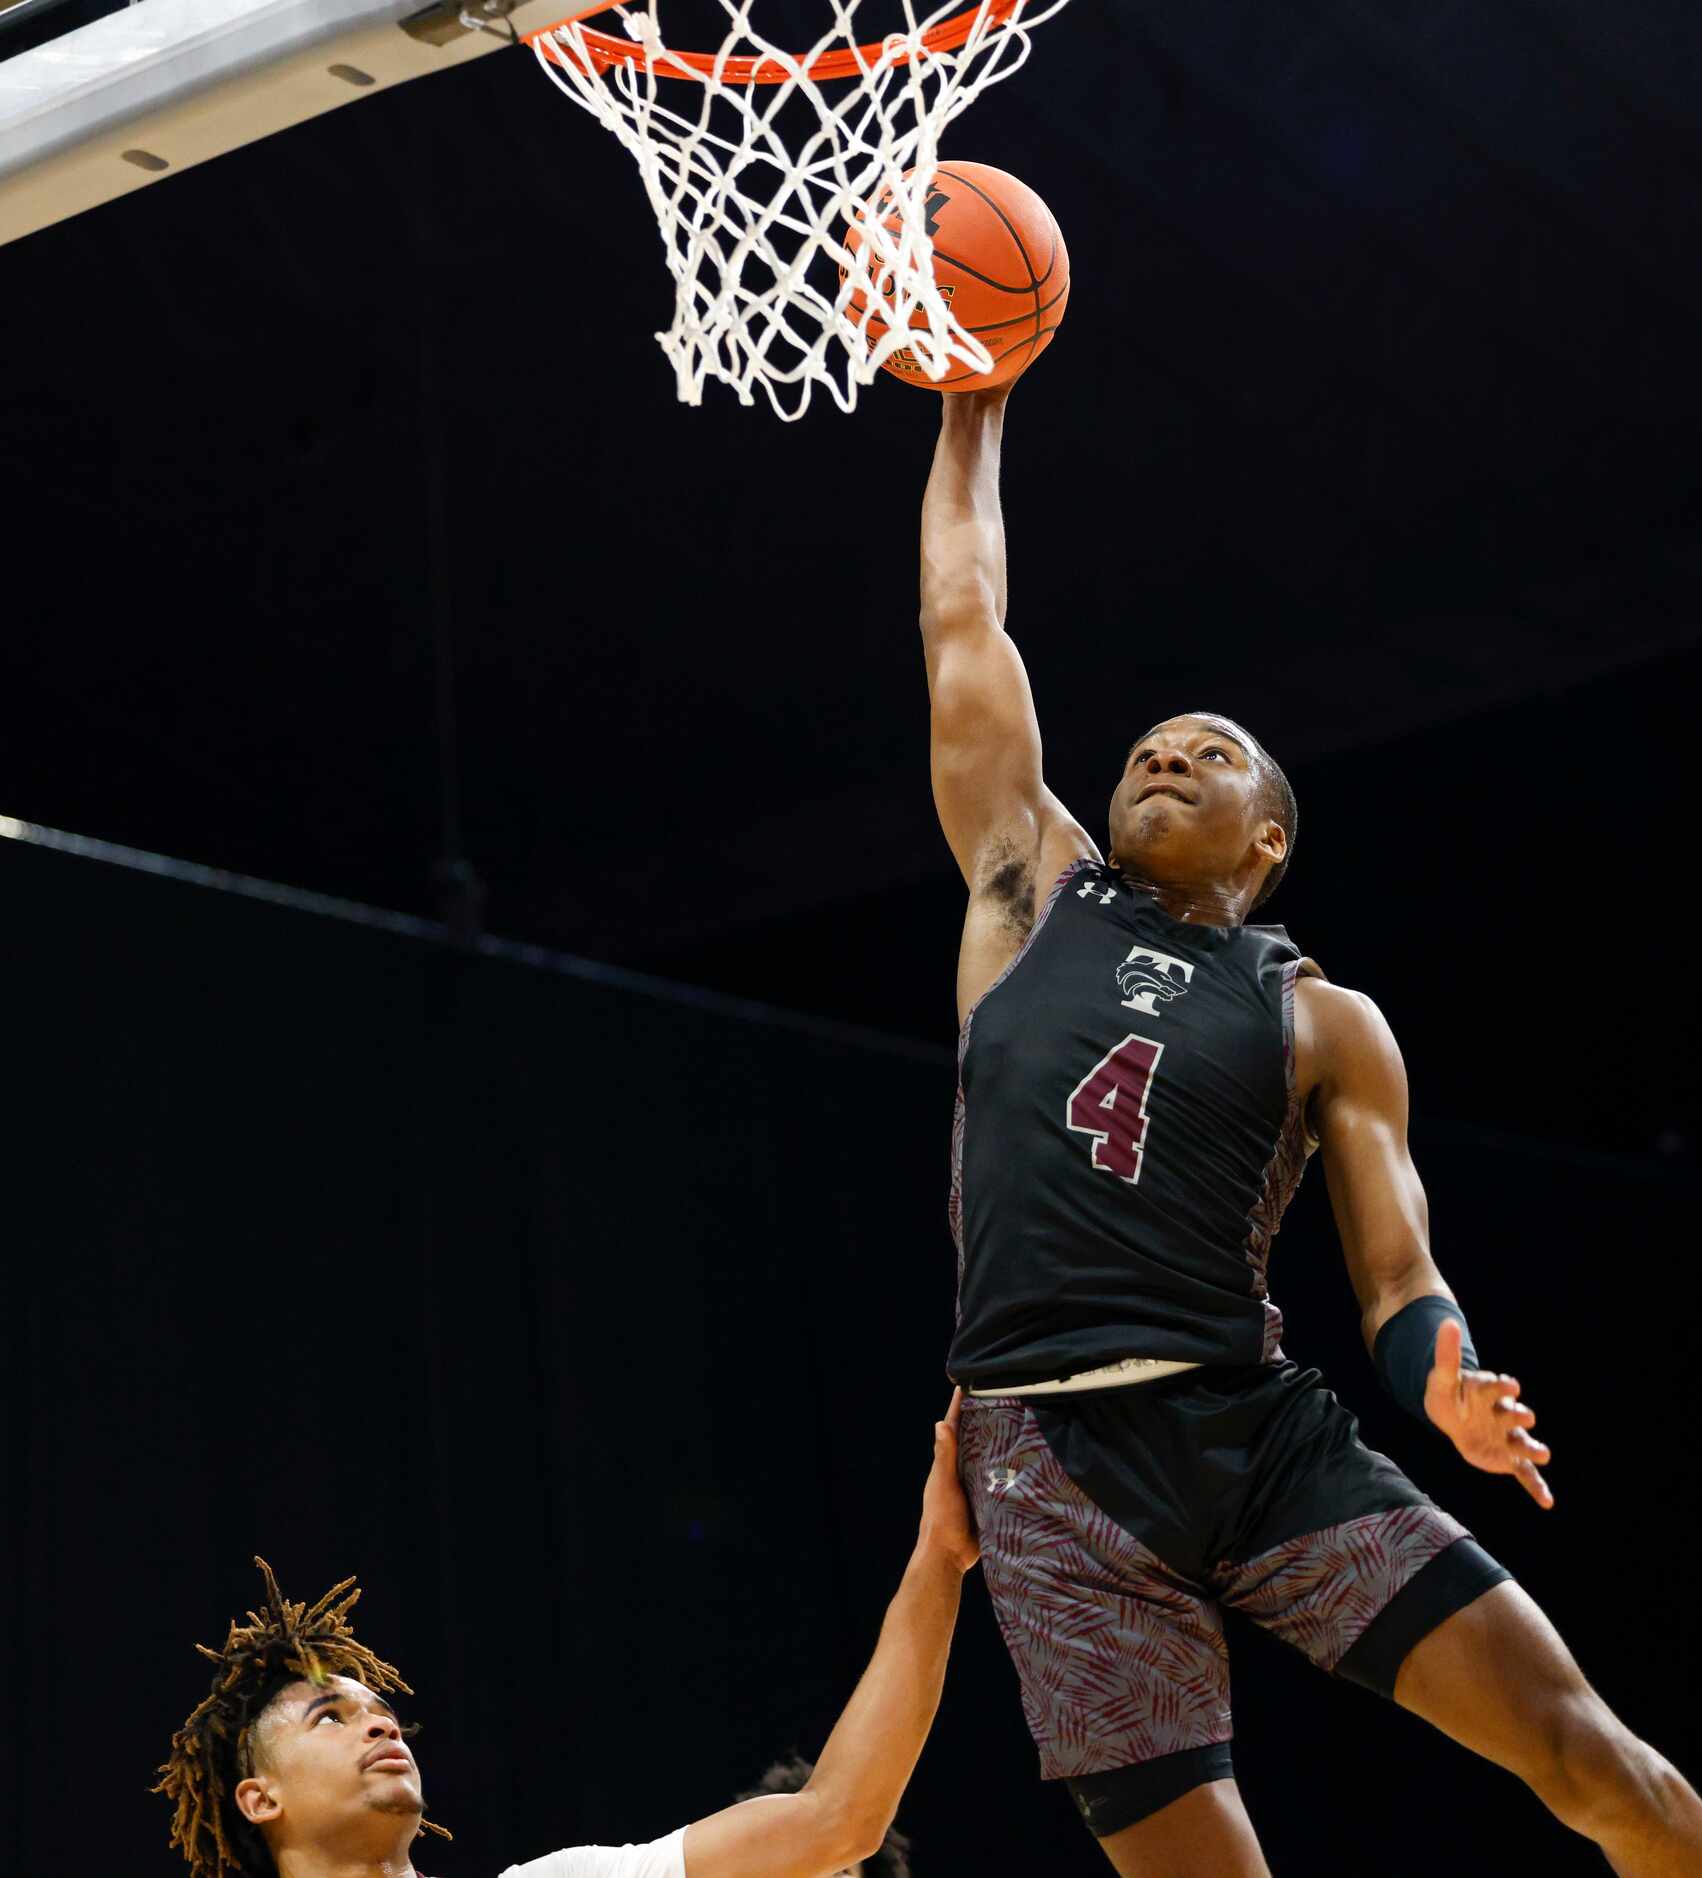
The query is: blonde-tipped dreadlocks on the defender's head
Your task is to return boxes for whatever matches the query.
[154,1559,449,1878]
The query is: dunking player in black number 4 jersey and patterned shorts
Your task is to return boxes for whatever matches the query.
[922,391,1702,1878]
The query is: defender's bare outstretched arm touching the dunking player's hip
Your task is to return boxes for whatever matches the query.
[672,1395,979,1878]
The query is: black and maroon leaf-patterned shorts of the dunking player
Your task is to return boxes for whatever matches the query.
[958,1363,1510,1833]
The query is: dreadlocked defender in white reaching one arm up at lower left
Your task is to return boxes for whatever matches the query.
[158,1401,975,1878]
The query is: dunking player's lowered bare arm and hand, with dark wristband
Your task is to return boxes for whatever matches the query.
[1296,978,1554,1506]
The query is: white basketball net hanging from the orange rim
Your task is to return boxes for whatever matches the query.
[534,0,1067,419]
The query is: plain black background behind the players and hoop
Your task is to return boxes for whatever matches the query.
[0,0,1702,1878]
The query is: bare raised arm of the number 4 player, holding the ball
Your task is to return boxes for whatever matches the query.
[922,385,1099,1003]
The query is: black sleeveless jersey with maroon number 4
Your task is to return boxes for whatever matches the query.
[949,860,1311,1388]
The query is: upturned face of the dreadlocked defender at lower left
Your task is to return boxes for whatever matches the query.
[239,1675,425,1846]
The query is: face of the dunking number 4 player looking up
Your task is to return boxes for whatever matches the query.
[1110,717,1264,883]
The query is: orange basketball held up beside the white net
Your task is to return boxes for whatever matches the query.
[842,163,1069,391]
